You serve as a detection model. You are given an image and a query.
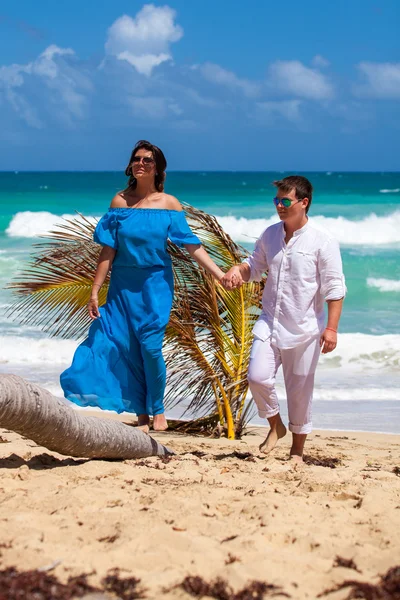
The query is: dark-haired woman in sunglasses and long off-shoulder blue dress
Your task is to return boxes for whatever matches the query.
[60,140,224,432]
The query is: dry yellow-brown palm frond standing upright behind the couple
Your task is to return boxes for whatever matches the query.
[9,206,263,439]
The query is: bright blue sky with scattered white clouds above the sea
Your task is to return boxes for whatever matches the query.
[0,0,400,171]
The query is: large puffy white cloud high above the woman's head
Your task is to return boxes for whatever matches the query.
[105,4,183,76]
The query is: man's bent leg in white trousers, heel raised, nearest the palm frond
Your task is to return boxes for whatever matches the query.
[247,337,286,454]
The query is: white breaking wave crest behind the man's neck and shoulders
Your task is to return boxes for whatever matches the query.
[217,211,400,246]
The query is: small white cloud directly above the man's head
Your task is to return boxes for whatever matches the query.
[268,60,333,100]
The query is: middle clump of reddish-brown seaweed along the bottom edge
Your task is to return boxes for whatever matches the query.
[164,575,290,600]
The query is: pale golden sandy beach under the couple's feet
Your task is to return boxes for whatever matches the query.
[0,412,400,600]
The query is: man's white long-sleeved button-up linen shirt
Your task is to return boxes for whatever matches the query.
[243,220,346,349]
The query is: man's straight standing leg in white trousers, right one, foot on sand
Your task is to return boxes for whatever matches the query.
[281,337,320,462]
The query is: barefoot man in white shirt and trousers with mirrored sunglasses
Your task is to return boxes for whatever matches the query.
[221,175,346,462]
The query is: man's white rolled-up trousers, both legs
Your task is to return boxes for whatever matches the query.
[247,336,321,433]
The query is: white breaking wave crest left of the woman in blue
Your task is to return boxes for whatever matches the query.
[6,211,95,238]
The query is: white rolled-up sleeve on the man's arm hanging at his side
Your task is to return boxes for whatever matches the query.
[318,239,347,301]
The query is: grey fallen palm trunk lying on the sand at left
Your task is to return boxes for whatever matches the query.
[0,375,173,459]
